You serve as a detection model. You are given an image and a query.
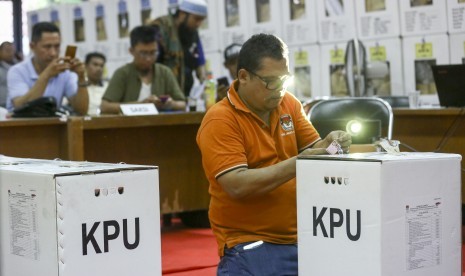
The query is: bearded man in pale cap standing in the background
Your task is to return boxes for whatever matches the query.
[150,0,207,96]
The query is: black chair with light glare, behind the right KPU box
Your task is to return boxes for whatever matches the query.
[308,97,393,144]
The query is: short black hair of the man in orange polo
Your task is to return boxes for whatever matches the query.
[237,34,289,76]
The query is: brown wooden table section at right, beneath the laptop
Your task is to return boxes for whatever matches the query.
[392,108,465,202]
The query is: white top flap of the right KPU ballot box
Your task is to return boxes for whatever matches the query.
[298,152,462,162]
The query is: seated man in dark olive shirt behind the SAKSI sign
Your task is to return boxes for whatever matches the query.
[100,26,186,114]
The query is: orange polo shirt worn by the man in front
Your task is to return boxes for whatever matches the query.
[197,82,320,256]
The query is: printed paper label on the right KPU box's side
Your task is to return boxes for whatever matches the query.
[405,198,442,270]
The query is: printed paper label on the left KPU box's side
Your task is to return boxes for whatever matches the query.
[8,190,39,260]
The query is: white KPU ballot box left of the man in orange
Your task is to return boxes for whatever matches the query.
[0,155,161,276]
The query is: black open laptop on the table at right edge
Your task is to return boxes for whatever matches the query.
[431,64,465,107]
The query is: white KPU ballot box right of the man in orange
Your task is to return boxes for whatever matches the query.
[297,152,461,276]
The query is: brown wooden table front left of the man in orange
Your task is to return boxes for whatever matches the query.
[0,112,209,214]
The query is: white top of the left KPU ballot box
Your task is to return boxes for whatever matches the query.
[0,155,158,176]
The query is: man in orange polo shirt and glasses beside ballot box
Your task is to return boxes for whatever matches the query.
[197,34,351,275]
